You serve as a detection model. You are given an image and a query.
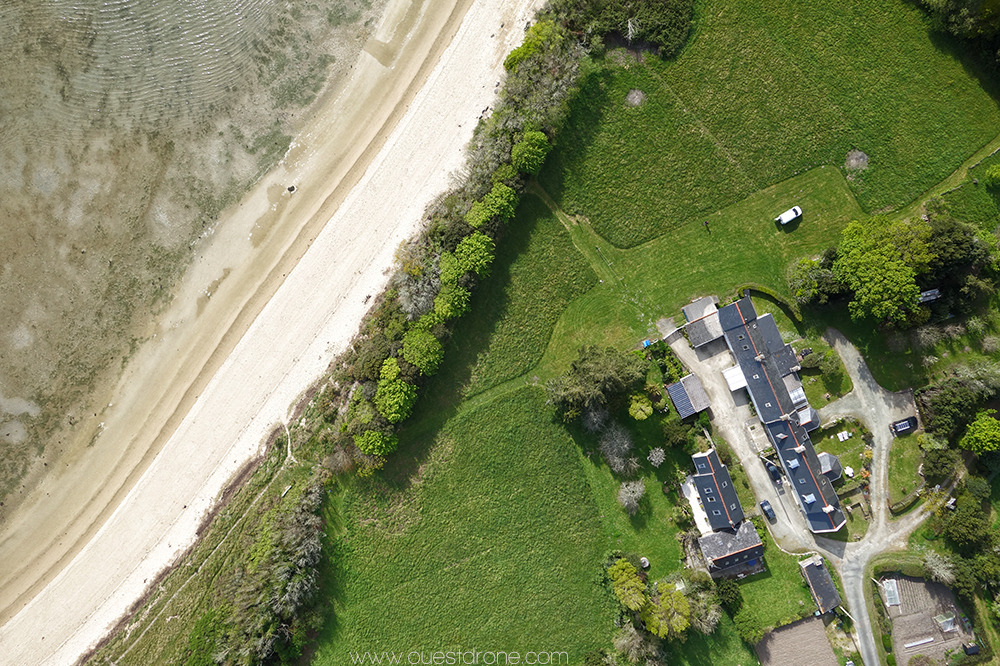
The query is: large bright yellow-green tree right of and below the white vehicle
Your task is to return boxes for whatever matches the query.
[833,216,934,325]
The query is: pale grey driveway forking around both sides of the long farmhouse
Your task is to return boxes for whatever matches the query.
[671,329,927,666]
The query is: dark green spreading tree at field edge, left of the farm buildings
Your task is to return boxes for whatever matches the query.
[546,347,647,418]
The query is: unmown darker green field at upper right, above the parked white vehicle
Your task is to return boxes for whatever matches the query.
[542,0,1000,247]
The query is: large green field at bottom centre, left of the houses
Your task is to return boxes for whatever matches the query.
[315,388,613,664]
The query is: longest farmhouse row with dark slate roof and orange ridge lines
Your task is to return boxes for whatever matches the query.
[719,297,847,533]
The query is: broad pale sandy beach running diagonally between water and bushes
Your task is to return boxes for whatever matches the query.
[0,0,541,664]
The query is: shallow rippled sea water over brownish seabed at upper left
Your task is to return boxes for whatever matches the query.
[0,0,382,500]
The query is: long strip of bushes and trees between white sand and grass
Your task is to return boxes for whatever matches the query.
[318,17,583,474]
